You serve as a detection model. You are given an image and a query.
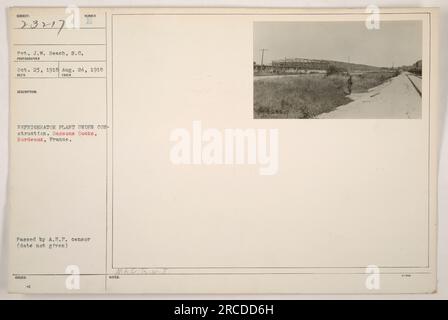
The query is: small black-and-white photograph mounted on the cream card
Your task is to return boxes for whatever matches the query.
[253,20,423,119]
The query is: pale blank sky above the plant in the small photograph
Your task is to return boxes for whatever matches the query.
[253,21,422,67]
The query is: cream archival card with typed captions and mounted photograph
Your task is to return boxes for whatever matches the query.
[7,7,442,295]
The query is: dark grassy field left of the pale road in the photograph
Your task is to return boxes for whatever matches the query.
[254,72,397,119]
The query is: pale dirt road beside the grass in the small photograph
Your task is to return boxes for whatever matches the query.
[317,73,421,119]
